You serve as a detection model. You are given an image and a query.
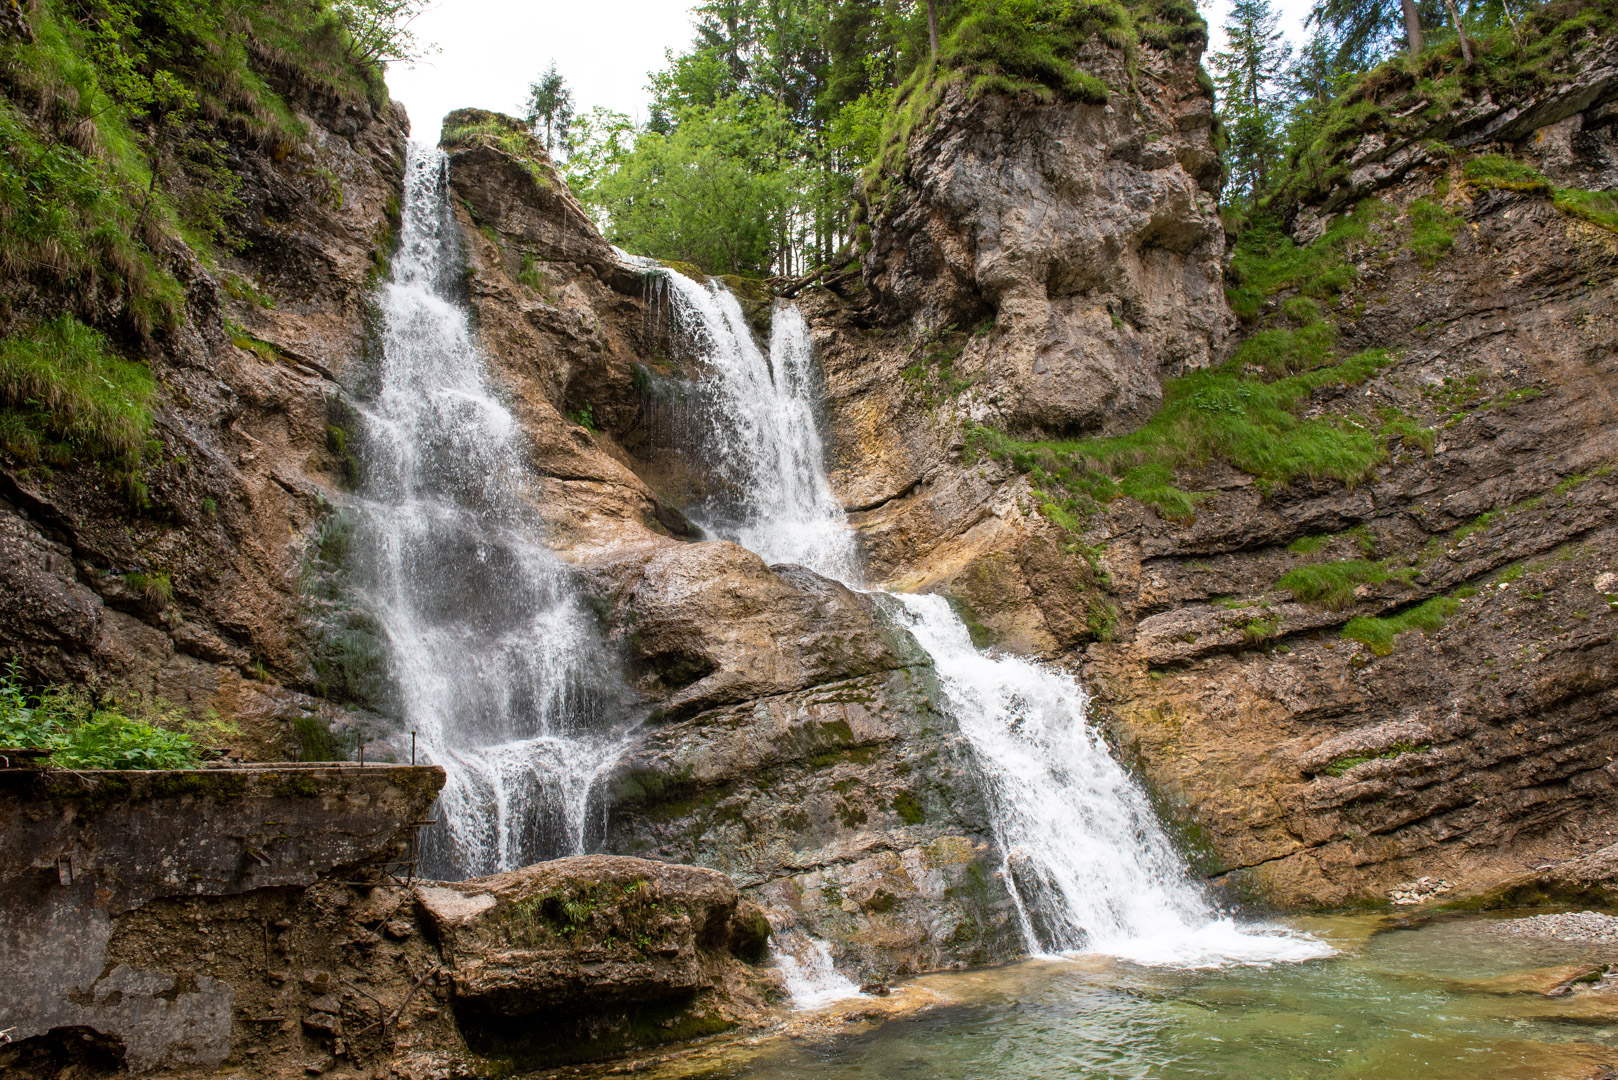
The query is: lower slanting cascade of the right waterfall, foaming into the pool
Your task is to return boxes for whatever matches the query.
[896,594,1330,967]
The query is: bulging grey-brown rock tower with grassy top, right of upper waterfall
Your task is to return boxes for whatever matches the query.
[864,44,1230,436]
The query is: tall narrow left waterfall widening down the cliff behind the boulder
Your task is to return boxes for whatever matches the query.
[354,144,626,878]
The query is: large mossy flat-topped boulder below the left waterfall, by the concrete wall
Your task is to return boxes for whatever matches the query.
[416,855,781,1069]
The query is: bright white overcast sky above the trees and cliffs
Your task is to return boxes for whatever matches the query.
[388,0,1311,142]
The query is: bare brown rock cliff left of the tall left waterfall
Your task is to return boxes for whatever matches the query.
[0,55,408,758]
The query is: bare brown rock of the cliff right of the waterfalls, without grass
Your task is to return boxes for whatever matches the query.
[804,29,1618,907]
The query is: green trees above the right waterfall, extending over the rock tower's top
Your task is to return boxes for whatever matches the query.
[556,0,1207,275]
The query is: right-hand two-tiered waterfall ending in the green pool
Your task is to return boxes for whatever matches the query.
[656,272,1330,971]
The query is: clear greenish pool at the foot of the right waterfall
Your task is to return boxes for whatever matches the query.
[559,915,1618,1080]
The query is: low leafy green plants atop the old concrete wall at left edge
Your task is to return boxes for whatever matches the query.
[0,662,201,769]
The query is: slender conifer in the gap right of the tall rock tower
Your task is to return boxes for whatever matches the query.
[1209,0,1291,202]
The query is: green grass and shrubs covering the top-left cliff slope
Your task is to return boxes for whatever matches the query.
[0,0,416,488]
